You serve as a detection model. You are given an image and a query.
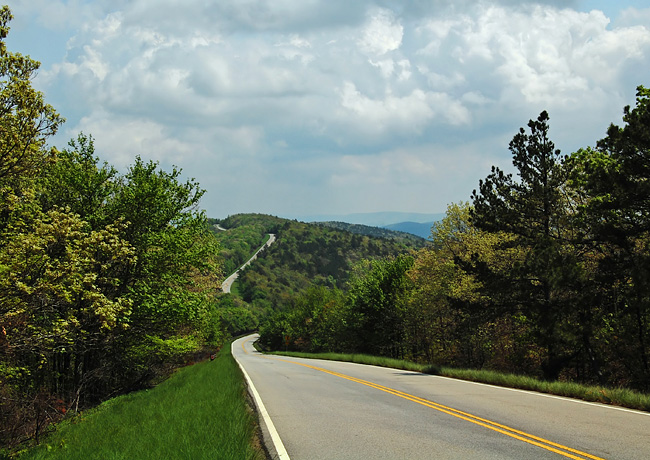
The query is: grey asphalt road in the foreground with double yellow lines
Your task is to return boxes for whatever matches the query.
[232,335,650,460]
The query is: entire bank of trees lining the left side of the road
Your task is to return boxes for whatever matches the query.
[0,6,251,456]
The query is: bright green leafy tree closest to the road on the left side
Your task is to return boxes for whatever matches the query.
[99,157,221,387]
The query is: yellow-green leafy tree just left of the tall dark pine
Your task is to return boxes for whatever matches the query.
[408,203,523,370]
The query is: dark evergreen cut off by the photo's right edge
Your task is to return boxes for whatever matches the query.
[572,86,650,389]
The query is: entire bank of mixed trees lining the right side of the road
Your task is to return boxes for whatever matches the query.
[258,92,650,391]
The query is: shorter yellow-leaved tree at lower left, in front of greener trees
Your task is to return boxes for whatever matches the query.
[0,210,134,397]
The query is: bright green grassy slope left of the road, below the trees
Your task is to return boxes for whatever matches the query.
[20,346,265,460]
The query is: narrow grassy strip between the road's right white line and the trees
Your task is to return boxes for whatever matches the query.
[272,352,650,412]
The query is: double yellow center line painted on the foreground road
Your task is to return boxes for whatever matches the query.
[274,358,604,460]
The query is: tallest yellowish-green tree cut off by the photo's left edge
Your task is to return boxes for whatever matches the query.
[0,6,71,447]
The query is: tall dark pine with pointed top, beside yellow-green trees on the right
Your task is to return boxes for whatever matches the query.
[471,111,575,379]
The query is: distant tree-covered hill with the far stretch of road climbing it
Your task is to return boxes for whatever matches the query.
[210,214,426,315]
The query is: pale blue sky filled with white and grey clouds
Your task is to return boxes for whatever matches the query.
[0,0,650,218]
